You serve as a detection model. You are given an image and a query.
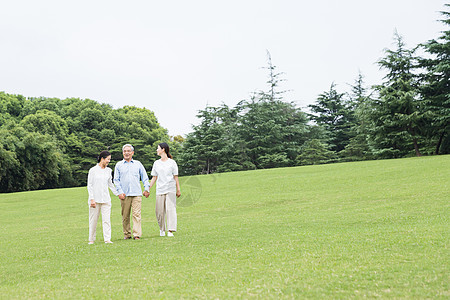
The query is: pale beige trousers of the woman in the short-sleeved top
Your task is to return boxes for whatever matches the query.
[155,193,177,231]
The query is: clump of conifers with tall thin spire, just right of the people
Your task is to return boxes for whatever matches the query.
[180,54,308,174]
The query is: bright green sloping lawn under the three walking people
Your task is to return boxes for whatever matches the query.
[0,155,450,299]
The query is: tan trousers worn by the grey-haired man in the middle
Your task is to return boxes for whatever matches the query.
[120,196,142,237]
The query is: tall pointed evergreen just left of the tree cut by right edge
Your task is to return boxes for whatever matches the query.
[370,33,425,158]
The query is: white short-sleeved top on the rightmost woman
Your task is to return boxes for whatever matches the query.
[152,158,178,195]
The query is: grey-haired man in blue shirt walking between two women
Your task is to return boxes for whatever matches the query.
[114,144,150,240]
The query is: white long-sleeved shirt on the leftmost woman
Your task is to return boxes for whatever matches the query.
[87,165,119,203]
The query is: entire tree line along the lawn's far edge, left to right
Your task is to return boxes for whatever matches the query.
[0,5,450,192]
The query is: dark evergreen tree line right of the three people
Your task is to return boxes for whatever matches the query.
[178,5,450,175]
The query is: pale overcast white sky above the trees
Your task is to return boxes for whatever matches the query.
[0,0,448,135]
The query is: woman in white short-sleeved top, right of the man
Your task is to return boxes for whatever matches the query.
[150,143,181,236]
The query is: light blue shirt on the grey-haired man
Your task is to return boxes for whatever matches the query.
[114,159,150,196]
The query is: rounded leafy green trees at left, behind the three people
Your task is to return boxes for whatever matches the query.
[0,92,181,192]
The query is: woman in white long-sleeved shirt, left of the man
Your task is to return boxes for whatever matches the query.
[87,151,119,244]
